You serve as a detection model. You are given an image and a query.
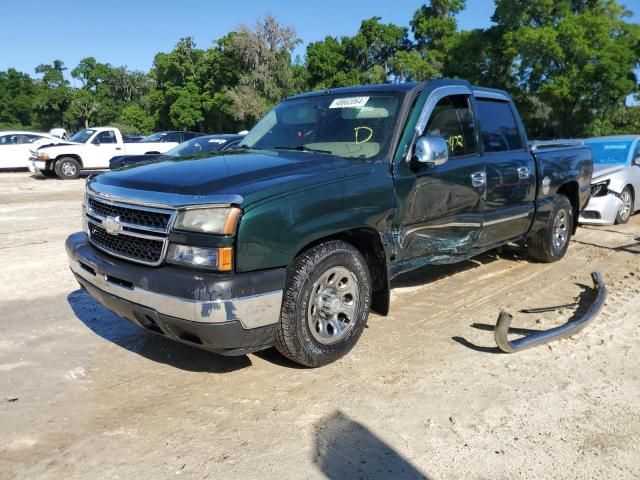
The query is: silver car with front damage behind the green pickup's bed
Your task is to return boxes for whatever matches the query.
[580,135,640,225]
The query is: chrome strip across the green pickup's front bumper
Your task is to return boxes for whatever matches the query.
[69,257,282,329]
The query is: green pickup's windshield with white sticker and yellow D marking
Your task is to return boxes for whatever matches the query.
[241,92,401,159]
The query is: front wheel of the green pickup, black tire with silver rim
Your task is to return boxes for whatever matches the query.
[275,240,371,367]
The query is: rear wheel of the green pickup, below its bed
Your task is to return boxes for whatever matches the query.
[527,195,574,263]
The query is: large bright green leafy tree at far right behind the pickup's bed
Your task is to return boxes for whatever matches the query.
[493,0,640,137]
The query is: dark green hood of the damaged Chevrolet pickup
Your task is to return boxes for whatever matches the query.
[89,150,372,206]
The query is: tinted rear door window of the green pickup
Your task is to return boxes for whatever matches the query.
[477,99,523,153]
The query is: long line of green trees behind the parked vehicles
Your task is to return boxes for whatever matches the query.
[0,7,640,138]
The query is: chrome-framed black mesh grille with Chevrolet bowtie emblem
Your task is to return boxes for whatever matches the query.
[86,197,175,265]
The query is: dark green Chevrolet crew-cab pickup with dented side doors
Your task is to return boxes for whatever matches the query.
[66,80,593,367]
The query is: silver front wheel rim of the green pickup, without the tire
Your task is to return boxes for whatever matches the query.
[307,267,360,345]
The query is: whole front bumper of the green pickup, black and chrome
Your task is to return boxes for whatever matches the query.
[66,233,285,355]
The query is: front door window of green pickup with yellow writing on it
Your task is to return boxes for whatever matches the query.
[424,95,478,158]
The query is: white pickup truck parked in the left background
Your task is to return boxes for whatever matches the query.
[29,127,178,179]
